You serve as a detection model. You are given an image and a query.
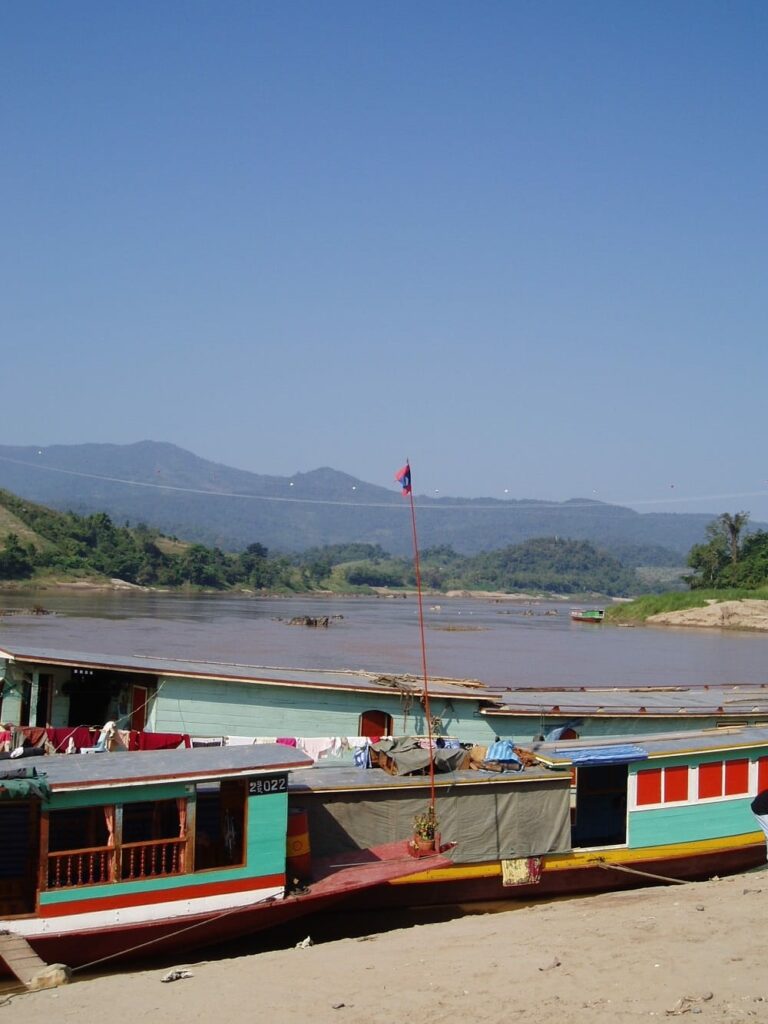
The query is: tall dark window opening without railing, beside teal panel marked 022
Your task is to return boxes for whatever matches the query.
[195,779,246,871]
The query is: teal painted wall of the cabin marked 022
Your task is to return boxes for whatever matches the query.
[40,783,288,905]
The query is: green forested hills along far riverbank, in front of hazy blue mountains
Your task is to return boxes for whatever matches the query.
[0,489,644,596]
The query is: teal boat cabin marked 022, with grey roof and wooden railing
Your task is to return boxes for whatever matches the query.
[0,745,311,964]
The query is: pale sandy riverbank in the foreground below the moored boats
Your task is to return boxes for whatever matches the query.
[10,869,768,1024]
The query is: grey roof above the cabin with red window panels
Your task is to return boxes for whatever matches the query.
[532,726,768,768]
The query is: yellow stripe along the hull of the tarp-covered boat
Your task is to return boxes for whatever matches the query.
[389,831,765,886]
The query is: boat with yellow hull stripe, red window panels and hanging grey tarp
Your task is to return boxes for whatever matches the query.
[290,727,768,906]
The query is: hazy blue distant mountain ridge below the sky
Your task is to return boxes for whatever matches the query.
[0,440,753,558]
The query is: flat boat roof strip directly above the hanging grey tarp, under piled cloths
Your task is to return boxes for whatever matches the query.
[288,765,559,798]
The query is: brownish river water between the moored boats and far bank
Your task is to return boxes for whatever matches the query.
[0,591,768,687]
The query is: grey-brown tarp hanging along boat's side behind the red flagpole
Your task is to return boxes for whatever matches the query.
[294,781,570,863]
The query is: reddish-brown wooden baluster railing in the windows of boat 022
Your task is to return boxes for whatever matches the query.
[48,838,186,889]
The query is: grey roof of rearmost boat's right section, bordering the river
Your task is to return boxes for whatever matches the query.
[489,683,768,716]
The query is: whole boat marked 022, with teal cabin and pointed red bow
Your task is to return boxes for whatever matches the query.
[0,744,439,967]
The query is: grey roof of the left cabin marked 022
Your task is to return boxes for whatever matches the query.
[12,743,312,792]
